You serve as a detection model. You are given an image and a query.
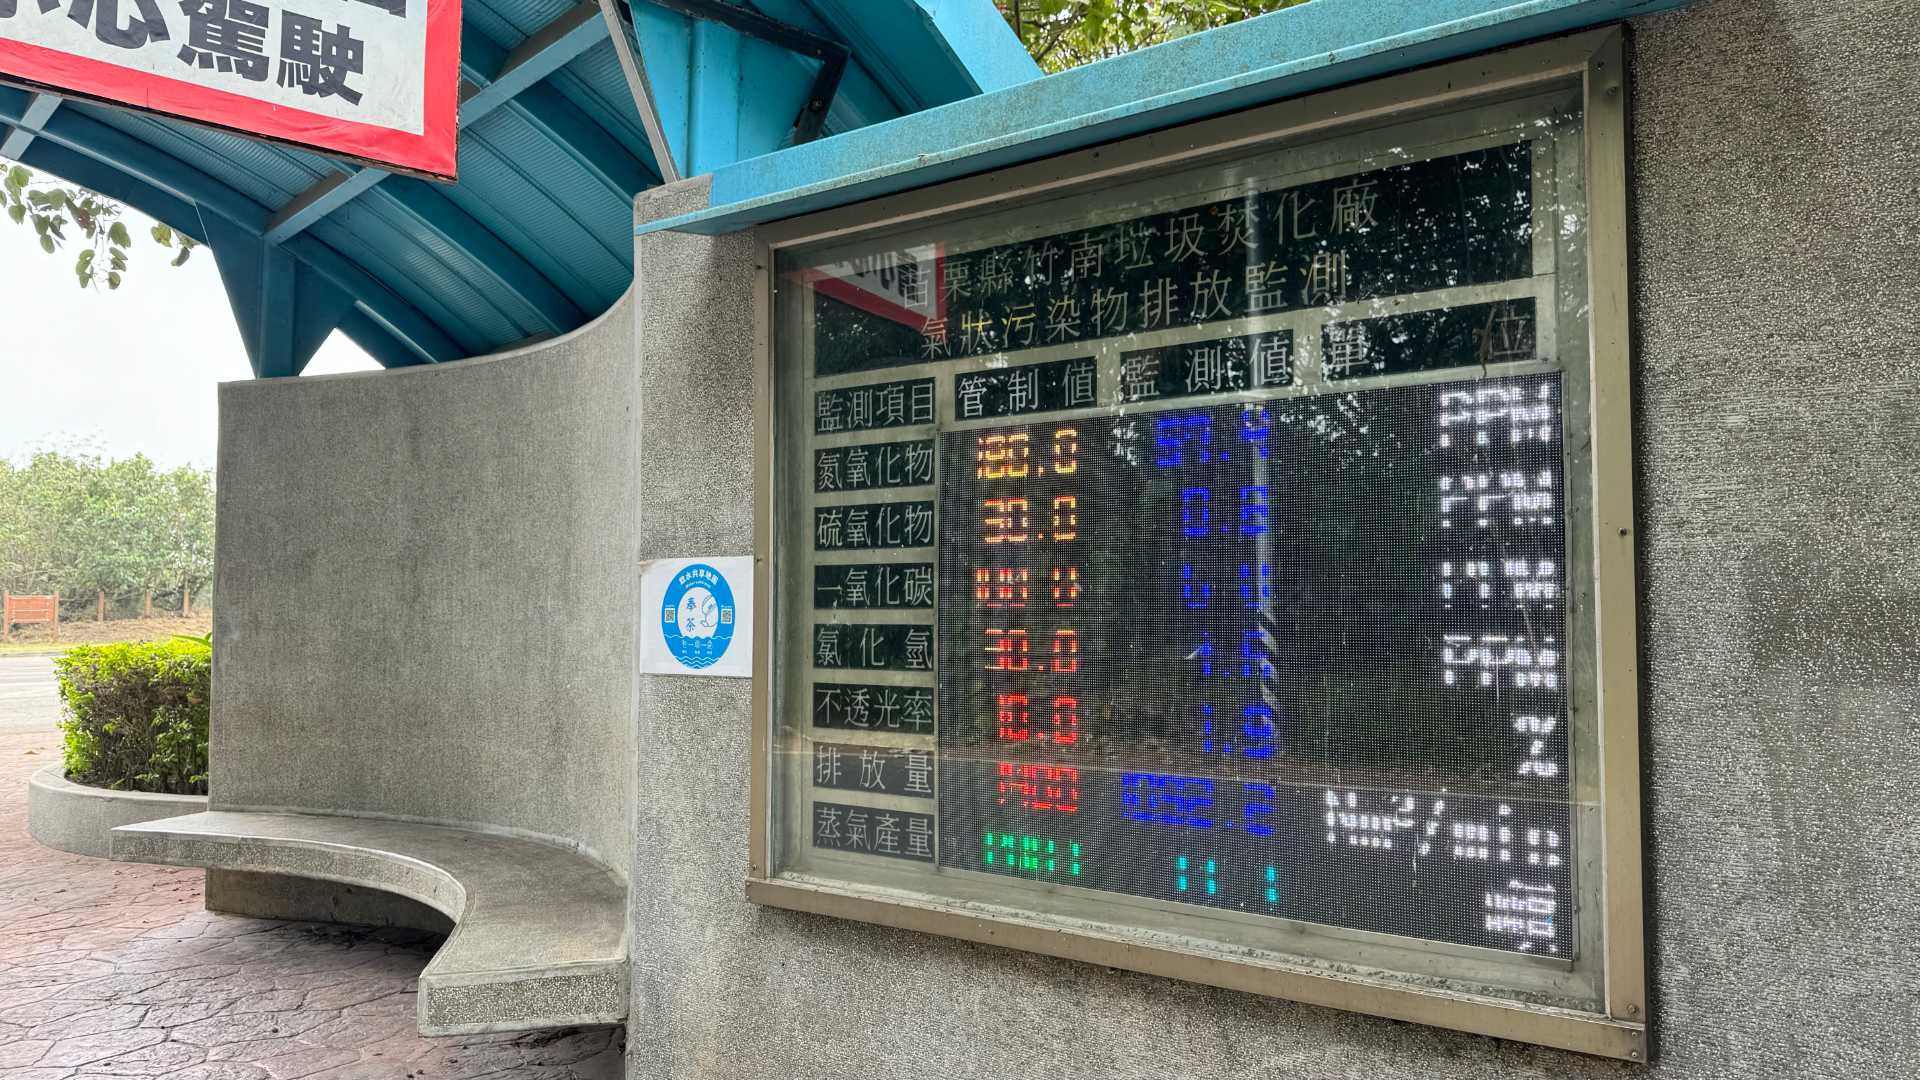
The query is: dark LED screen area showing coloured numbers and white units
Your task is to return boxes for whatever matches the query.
[939,375,1572,953]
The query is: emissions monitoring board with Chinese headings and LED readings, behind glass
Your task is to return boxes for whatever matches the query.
[755,37,1638,1057]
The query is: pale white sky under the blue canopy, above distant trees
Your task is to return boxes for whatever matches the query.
[0,191,378,469]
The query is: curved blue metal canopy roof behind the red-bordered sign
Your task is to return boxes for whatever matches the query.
[0,0,1039,377]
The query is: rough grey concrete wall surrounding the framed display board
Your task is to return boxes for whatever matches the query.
[633,0,1920,1080]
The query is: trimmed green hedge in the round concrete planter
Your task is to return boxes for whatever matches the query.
[54,638,213,796]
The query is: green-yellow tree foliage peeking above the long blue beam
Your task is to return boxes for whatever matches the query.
[995,0,1308,71]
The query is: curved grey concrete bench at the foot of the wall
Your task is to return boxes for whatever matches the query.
[113,811,628,1036]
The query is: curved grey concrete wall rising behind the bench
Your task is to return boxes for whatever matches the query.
[211,298,637,872]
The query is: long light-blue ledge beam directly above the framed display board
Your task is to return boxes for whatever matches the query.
[636,0,1688,233]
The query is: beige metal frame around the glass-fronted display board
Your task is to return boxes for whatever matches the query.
[745,27,1649,1061]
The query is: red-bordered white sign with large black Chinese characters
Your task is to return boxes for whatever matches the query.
[0,0,461,179]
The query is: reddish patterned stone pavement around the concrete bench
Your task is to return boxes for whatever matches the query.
[0,730,622,1080]
